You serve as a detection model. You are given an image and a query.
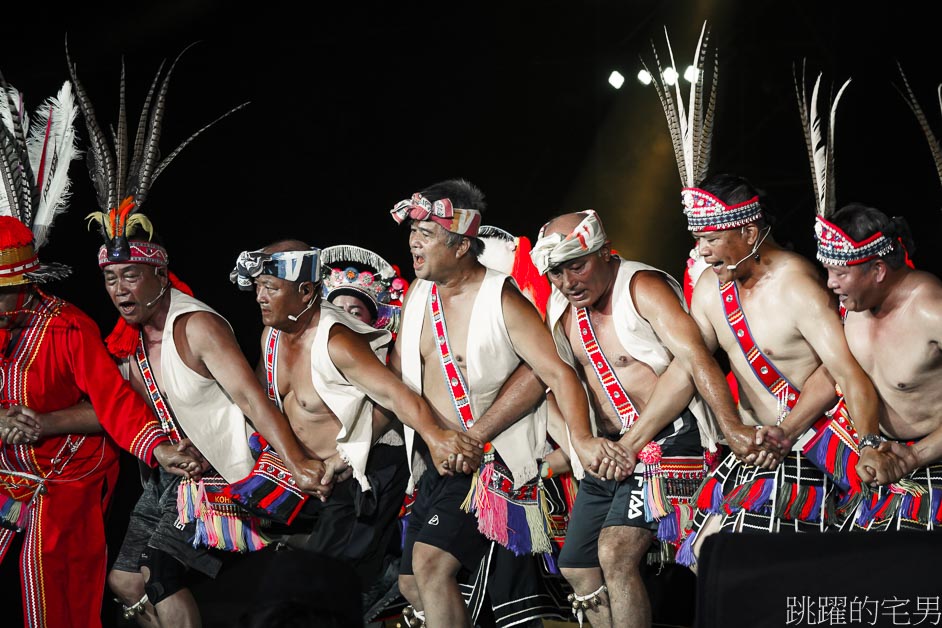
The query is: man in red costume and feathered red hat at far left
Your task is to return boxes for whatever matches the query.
[0,76,200,628]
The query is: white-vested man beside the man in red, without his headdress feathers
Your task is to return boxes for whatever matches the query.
[98,238,329,626]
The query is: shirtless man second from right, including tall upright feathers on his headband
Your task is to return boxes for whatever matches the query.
[653,31,896,565]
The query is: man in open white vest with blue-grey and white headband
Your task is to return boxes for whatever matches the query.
[233,240,481,586]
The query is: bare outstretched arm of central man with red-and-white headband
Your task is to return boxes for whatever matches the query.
[501,286,634,480]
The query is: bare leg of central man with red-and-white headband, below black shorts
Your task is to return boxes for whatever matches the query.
[412,543,471,628]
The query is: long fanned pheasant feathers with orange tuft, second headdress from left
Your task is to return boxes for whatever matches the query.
[66,44,248,265]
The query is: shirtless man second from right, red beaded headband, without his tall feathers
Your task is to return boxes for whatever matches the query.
[684,174,898,562]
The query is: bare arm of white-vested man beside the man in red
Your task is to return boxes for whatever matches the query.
[184,312,326,497]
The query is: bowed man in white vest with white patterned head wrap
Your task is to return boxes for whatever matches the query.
[532,210,732,627]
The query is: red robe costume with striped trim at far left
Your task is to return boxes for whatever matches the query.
[0,292,169,628]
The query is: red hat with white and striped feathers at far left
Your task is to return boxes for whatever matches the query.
[0,74,78,285]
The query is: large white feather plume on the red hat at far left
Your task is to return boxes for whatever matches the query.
[27,81,79,250]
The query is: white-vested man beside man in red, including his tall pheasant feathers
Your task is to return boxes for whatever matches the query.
[69,53,329,626]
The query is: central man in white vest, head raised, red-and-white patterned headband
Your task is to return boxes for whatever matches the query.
[390,180,628,628]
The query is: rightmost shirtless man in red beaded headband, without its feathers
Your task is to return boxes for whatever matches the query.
[817,204,942,530]
